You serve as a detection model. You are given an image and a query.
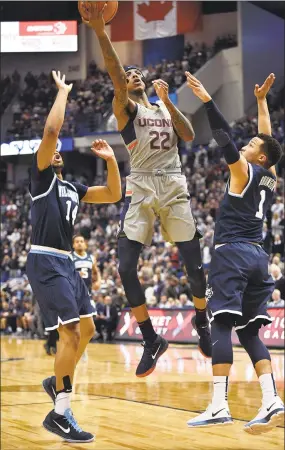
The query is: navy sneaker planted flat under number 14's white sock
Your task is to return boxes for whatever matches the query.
[43,409,95,443]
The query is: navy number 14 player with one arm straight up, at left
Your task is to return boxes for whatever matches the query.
[27,72,121,442]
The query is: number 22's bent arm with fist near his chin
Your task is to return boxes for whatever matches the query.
[153,79,195,142]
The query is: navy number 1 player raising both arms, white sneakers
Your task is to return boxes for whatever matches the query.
[187,73,284,434]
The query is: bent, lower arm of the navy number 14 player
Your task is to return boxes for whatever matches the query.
[82,139,122,203]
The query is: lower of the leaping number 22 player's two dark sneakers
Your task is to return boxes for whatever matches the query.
[136,336,168,377]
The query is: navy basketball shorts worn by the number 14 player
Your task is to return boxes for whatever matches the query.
[27,251,96,330]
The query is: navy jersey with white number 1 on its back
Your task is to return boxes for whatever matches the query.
[214,164,276,244]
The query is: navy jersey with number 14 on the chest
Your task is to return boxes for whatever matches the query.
[29,155,88,251]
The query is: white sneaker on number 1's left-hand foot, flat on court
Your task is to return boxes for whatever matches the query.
[187,402,234,428]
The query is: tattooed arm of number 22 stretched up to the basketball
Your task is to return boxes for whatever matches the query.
[82,2,135,119]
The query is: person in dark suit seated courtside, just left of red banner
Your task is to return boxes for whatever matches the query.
[94,295,118,341]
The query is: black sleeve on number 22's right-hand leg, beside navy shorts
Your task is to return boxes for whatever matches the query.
[176,237,206,298]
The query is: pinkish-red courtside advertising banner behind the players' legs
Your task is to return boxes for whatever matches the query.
[115,308,284,348]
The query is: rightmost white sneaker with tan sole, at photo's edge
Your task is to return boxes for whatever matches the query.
[243,397,285,434]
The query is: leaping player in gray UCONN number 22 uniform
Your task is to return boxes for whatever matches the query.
[84,2,211,377]
